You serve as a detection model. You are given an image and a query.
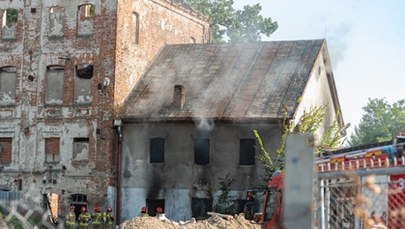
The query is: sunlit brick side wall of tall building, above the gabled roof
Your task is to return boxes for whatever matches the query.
[115,0,209,104]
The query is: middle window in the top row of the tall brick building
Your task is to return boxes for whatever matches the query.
[49,6,65,38]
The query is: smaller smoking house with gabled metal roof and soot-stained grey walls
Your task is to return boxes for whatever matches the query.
[118,40,343,220]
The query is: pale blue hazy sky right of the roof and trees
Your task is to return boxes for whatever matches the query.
[234,0,405,135]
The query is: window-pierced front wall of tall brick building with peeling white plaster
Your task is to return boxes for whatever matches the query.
[0,0,116,211]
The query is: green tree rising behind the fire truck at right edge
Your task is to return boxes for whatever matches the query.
[348,98,405,146]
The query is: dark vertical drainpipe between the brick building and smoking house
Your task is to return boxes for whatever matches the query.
[114,119,122,225]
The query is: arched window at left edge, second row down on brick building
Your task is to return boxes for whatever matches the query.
[0,66,17,105]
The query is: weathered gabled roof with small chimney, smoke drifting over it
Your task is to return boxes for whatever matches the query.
[122,40,325,121]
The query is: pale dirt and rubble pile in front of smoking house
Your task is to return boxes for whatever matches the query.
[120,213,261,229]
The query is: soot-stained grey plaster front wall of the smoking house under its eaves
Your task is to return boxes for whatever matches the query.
[121,122,281,220]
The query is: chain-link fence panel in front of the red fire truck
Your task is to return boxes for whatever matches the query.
[314,166,405,229]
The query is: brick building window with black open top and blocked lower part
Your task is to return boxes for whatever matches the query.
[74,64,93,104]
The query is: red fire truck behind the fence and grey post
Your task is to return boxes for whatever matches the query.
[260,135,405,229]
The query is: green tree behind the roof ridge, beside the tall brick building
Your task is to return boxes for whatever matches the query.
[186,0,278,42]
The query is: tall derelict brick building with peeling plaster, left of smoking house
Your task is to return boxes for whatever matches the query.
[0,0,209,224]
